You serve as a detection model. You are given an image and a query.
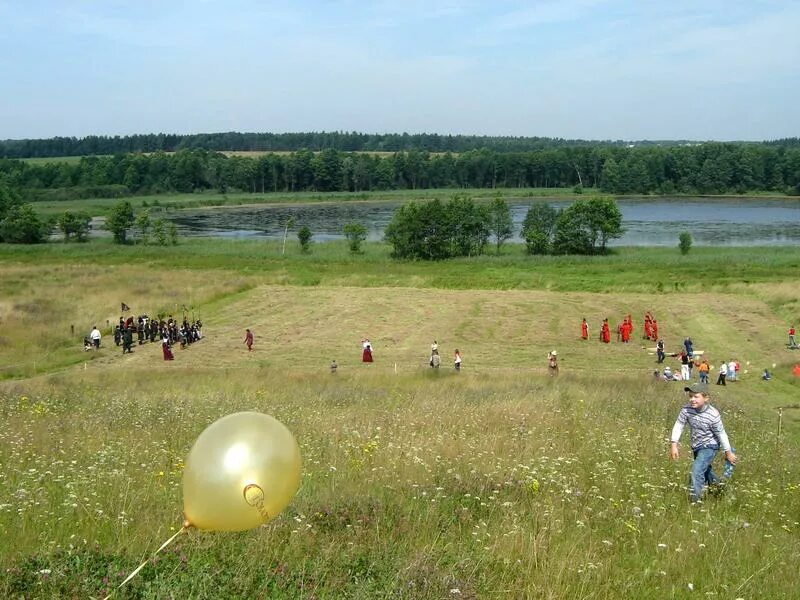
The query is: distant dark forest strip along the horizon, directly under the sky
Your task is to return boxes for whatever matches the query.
[0,131,800,158]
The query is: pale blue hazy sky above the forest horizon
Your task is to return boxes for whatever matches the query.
[0,0,800,141]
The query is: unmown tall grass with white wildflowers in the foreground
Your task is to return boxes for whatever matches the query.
[0,366,800,598]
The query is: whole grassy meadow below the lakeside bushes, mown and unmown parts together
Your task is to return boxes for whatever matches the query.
[0,240,800,598]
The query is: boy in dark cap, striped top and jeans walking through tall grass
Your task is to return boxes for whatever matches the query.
[670,383,737,503]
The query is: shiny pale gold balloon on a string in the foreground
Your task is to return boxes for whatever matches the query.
[183,412,300,531]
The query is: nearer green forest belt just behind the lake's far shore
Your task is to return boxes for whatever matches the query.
[0,142,800,201]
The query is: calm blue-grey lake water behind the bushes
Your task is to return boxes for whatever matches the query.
[169,198,800,246]
